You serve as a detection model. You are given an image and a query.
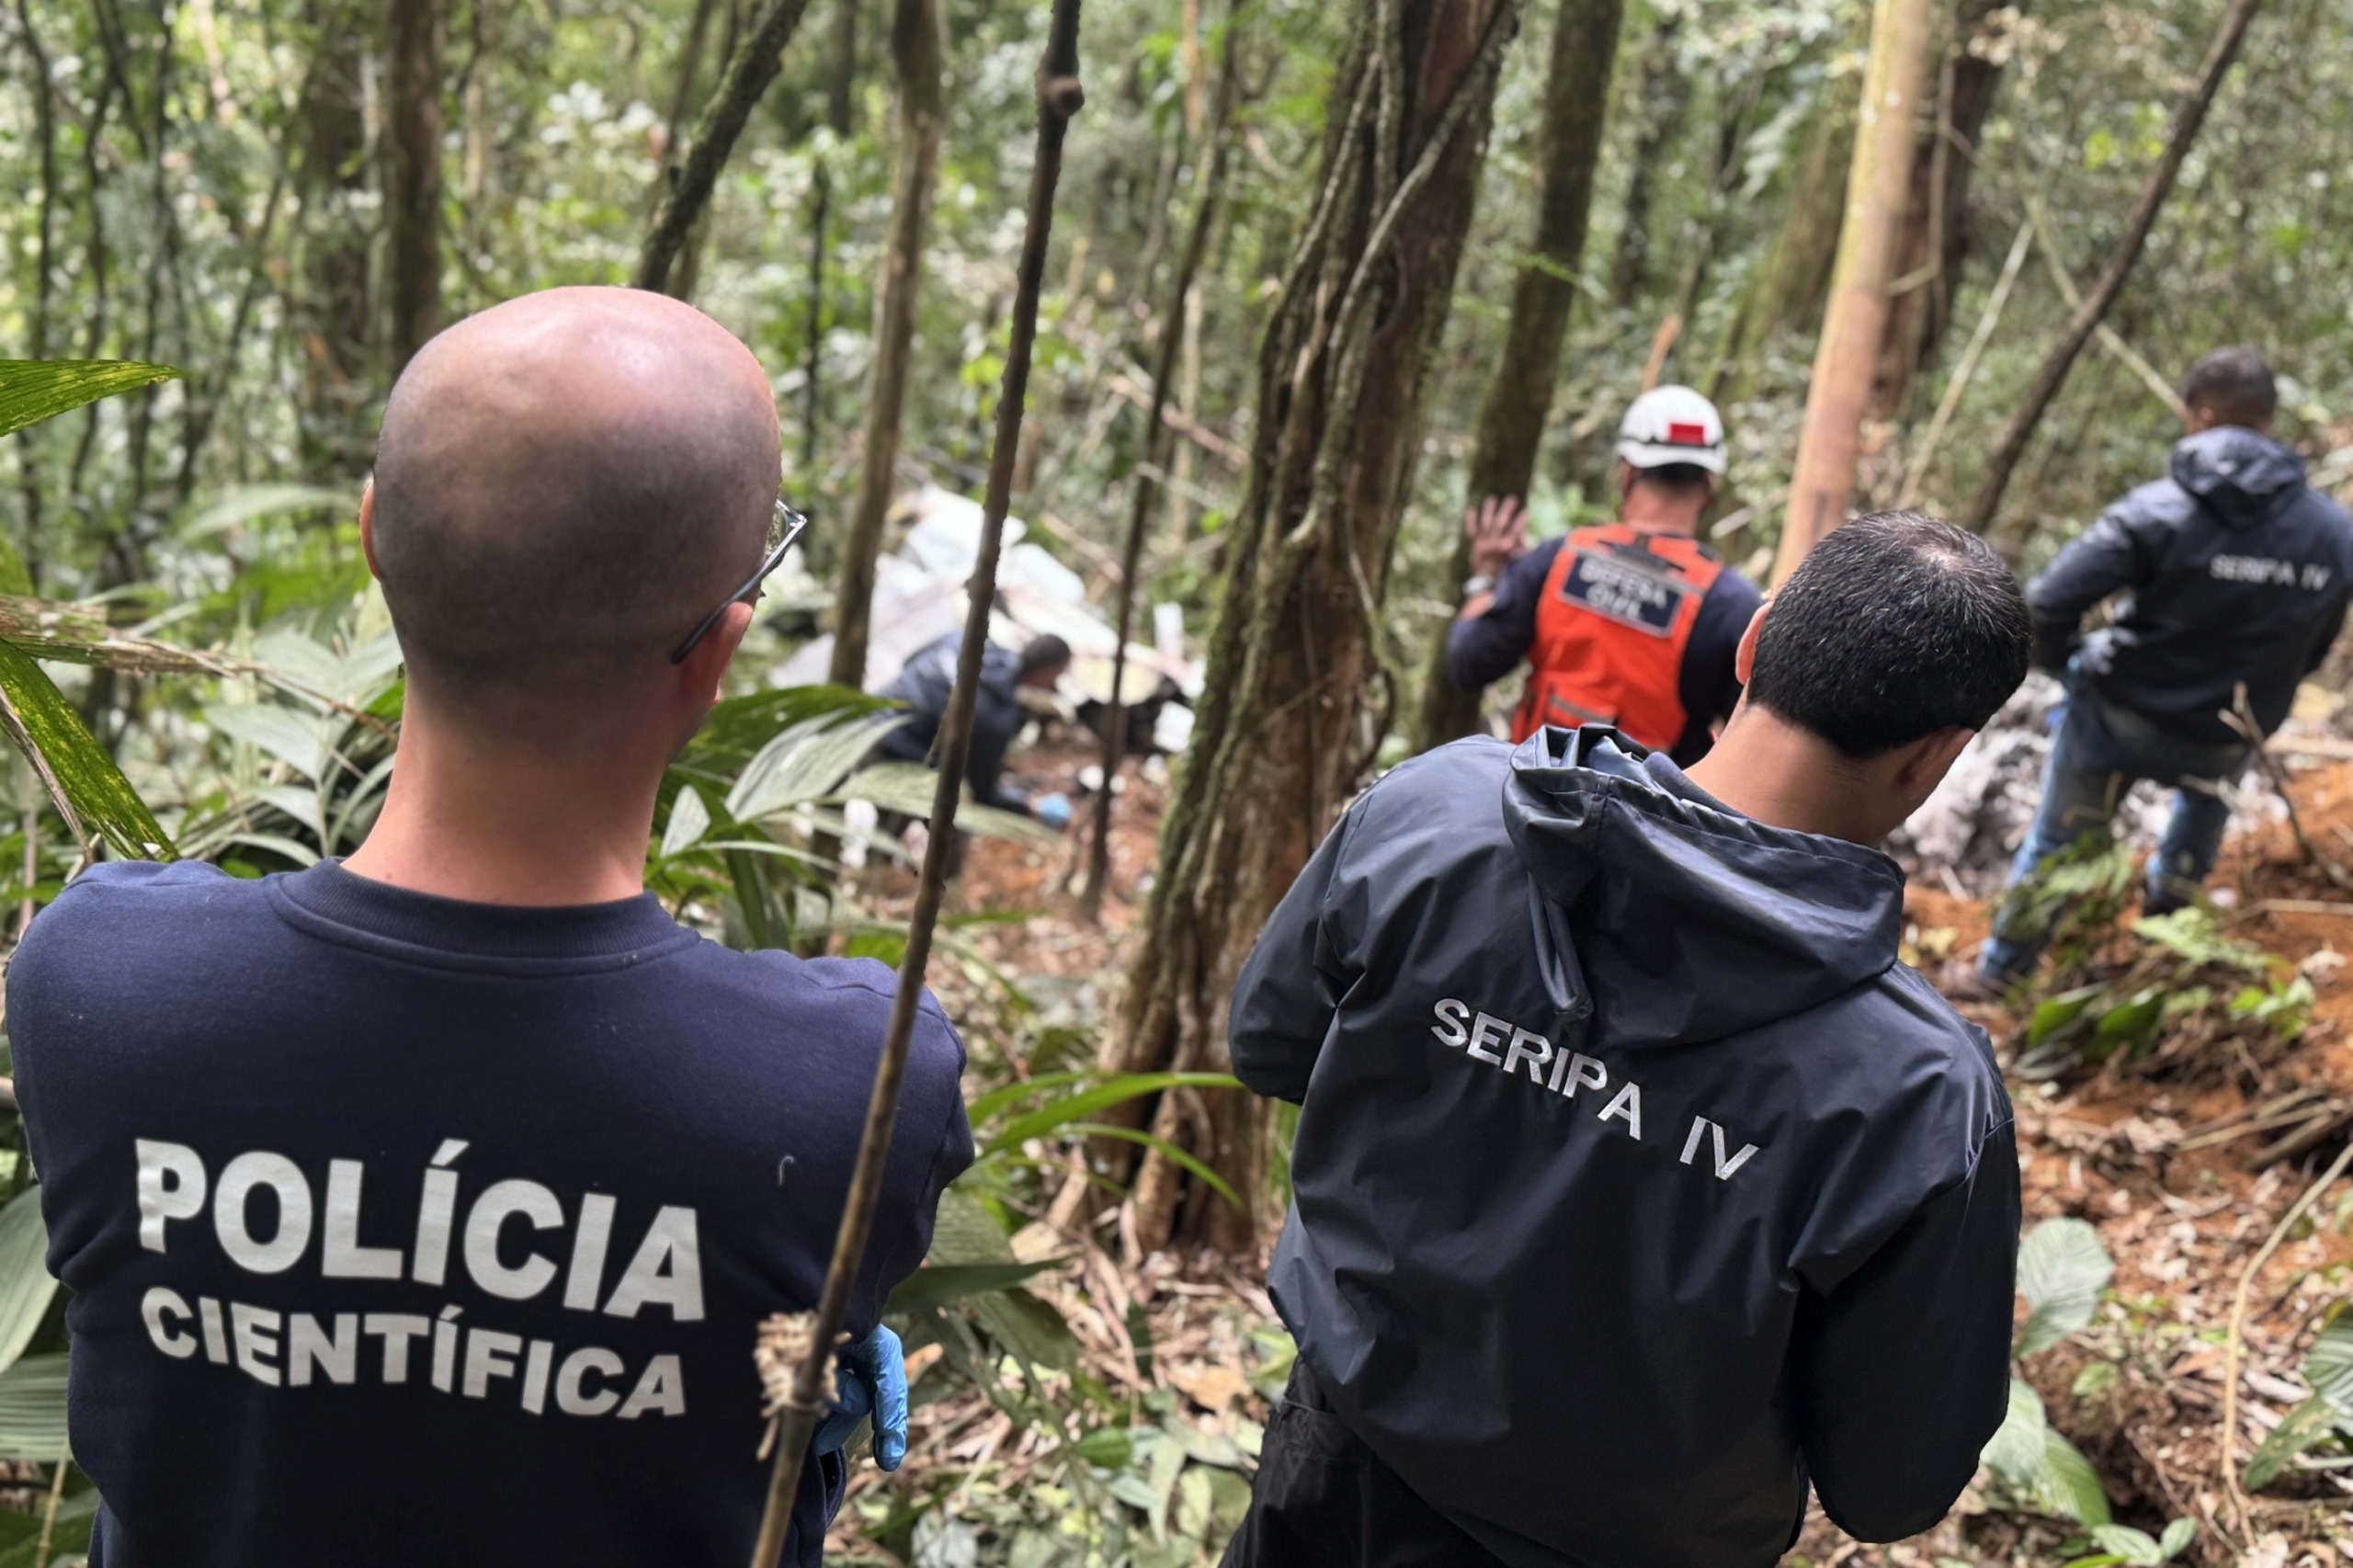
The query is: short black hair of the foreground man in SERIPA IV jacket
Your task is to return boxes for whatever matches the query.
[1748,511,2030,758]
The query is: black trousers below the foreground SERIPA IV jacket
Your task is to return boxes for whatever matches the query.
[1223,1361,1504,1568]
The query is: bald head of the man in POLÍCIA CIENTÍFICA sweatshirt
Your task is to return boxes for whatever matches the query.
[371,288,779,711]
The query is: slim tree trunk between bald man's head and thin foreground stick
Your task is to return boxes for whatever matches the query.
[826,0,949,685]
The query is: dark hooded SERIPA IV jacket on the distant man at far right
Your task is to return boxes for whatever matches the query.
[2026,426,2353,746]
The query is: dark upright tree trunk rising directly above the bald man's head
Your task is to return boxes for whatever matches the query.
[383,0,447,379]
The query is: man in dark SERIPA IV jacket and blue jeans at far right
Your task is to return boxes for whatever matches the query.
[1976,348,2353,989]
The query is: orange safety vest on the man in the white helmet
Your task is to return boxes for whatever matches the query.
[1511,523,1724,751]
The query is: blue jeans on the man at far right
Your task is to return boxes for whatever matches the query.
[1976,678,2249,982]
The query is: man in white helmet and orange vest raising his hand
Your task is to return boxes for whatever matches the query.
[1447,386,1762,766]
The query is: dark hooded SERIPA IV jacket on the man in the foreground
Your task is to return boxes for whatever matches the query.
[1233,730,2018,1568]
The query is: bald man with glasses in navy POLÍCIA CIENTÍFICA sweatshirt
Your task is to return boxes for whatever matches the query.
[7,290,972,1568]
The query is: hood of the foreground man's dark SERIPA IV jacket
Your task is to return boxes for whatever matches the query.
[1504,728,1904,1048]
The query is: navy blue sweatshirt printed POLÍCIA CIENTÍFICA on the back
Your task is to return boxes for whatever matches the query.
[7,862,972,1568]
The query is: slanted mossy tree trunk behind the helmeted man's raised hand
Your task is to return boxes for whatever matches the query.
[1415,0,1628,751]
